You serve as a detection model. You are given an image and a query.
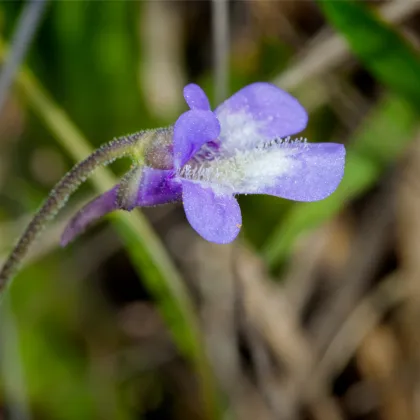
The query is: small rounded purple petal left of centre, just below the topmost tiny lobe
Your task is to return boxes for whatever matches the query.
[174,110,220,169]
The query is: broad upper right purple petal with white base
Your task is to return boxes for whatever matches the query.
[215,82,308,150]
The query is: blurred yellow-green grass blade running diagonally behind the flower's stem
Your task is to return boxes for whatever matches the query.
[0,36,220,418]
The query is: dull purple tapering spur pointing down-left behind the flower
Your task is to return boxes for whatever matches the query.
[61,185,119,246]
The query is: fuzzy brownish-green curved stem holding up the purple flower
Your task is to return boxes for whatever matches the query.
[0,131,148,292]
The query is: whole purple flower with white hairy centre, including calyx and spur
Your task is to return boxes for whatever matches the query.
[62,83,345,245]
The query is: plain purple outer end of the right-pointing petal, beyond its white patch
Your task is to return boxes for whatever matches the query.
[257,143,346,201]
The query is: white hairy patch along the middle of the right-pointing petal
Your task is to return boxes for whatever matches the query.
[179,140,302,194]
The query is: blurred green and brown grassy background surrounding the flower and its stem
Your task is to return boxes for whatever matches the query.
[0,0,420,420]
